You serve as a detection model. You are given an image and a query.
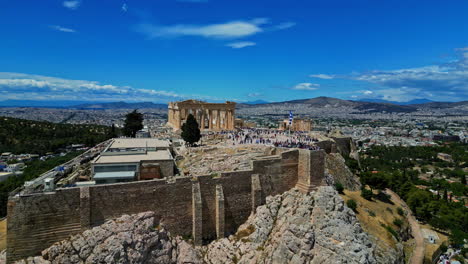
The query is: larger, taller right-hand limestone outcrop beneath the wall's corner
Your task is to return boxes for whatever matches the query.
[201,187,376,264]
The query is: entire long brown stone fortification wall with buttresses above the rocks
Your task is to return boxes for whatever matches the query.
[7,150,325,262]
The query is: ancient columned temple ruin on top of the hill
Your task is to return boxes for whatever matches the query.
[168,100,236,131]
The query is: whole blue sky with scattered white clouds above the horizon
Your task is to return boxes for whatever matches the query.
[0,0,468,102]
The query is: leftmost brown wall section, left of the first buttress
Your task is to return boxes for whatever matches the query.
[7,189,81,260]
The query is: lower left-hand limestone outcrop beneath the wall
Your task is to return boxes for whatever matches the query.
[11,212,200,264]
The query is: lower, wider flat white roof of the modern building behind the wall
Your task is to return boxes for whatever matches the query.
[92,150,172,164]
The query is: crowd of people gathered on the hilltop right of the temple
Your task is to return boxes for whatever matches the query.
[219,128,320,150]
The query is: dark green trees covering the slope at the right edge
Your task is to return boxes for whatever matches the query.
[356,143,468,253]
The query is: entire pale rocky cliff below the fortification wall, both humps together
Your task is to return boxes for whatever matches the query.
[5,186,402,264]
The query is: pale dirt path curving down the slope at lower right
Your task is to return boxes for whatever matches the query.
[385,189,424,264]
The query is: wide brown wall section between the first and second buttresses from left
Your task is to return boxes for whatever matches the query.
[89,177,192,235]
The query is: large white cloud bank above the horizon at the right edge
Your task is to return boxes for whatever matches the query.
[318,47,468,102]
